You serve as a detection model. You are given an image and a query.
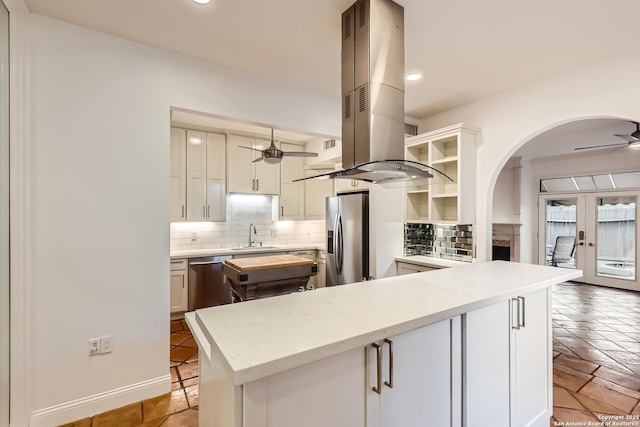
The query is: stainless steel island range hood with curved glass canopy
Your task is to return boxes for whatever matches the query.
[296,0,453,187]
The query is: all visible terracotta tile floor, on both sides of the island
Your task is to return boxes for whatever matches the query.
[64,283,640,427]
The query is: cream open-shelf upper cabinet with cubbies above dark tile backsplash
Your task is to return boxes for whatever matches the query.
[405,124,479,224]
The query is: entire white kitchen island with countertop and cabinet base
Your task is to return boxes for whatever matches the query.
[187,261,581,427]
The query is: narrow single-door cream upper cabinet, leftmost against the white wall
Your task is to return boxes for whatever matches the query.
[169,128,187,222]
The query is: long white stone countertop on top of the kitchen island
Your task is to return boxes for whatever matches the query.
[187,261,582,385]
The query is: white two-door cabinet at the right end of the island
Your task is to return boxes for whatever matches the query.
[464,288,553,427]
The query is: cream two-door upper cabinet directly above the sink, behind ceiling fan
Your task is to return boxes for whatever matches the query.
[227,135,280,194]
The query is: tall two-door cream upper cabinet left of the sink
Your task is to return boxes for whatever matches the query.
[186,130,227,221]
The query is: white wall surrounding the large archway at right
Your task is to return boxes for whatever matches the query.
[420,48,640,261]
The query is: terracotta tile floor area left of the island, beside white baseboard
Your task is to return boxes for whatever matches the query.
[64,320,198,427]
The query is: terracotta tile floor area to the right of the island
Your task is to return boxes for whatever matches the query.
[550,283,640,427]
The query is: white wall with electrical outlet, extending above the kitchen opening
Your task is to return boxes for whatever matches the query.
[26,15,340,425]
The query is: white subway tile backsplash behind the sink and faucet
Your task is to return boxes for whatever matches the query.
[170,194,325,251]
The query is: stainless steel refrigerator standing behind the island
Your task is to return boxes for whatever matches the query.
[326,193,369,286]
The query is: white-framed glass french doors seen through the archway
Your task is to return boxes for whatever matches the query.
[538,190,640,290]
